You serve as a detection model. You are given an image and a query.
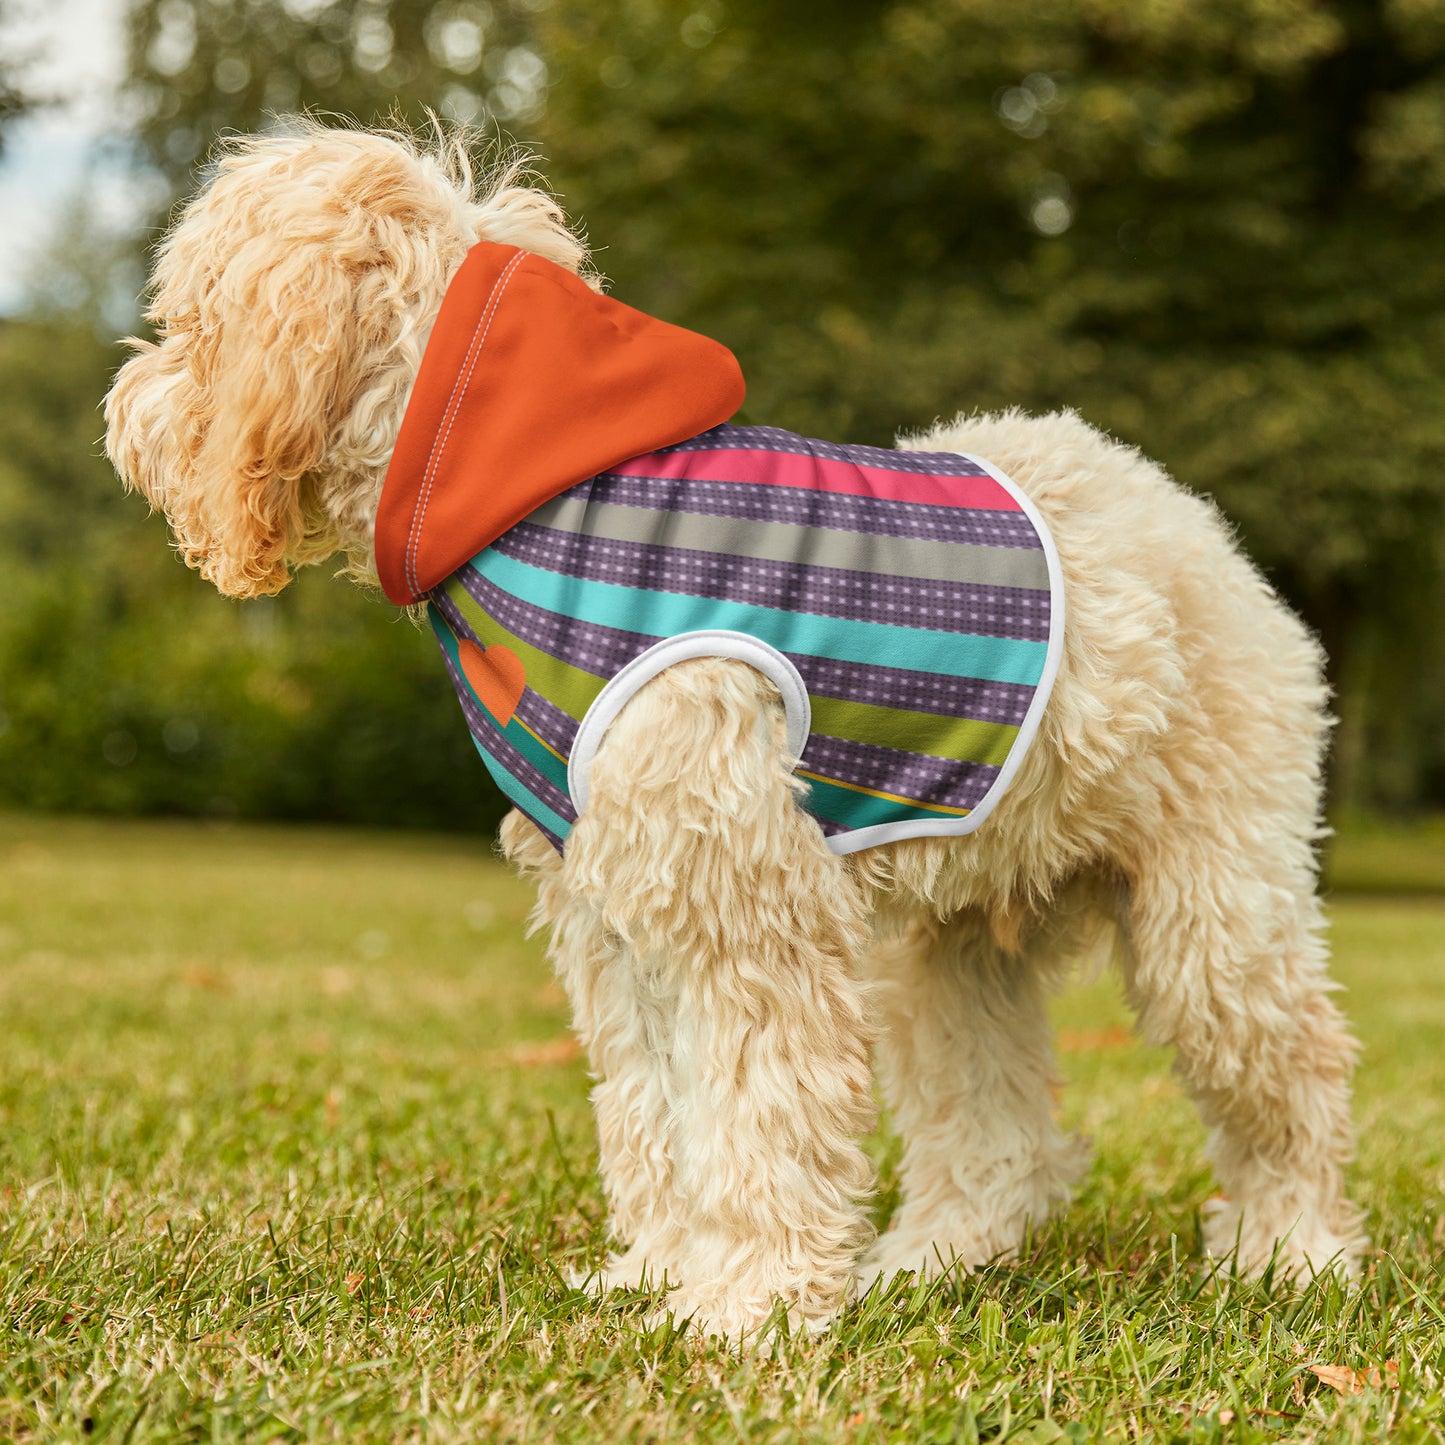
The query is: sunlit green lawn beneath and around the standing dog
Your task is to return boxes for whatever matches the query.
[0,818,1445,1445]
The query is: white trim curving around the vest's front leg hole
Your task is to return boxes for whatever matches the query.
[566,627,814,831]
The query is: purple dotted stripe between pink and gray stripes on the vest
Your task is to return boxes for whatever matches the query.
[586,473,1043,551]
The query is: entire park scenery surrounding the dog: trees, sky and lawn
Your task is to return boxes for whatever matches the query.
[0,0,1445,1445]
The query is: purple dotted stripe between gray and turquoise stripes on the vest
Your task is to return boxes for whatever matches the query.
[493,522,1049,642]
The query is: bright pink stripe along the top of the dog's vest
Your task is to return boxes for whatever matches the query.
[607,447,1022,512]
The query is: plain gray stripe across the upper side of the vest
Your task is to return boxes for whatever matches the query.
[527,493,1049,591]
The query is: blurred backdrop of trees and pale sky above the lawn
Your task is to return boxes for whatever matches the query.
[0,0,1445,828]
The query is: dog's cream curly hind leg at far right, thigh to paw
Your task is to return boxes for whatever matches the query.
[1097,580,1364,1274]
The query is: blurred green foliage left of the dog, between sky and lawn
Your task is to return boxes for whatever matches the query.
[0,315,500,827]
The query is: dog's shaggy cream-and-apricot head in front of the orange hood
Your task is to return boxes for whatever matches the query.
[105,121,585,597]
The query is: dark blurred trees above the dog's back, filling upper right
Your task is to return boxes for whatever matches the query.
[540,0,1445,805]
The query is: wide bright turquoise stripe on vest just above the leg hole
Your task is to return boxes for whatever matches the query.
[467,548,1049,688]
